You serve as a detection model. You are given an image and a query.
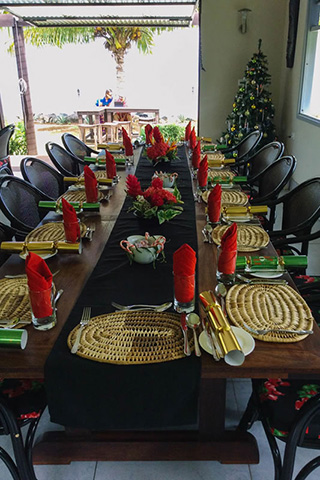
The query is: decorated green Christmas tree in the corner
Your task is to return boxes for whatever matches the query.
[220,39,275,147]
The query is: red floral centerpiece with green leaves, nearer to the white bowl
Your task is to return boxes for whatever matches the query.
[126,175,183,224]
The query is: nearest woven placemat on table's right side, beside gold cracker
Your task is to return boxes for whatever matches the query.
[226,284,313,342]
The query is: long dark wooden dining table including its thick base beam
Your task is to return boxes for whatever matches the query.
[0,146,320,464]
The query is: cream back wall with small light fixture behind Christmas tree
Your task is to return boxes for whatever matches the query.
[199,0,288,140]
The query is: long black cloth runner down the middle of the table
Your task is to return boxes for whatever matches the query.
[45,148,201,430]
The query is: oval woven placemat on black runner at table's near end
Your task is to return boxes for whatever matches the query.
[68,310,193,365]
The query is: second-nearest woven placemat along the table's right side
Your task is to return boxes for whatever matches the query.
[212,225,270,252]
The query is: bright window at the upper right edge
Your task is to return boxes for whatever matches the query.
[299,0,320,125]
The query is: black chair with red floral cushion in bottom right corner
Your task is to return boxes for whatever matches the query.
[238,378,320,480]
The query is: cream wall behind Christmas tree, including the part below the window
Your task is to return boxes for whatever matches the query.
[199,0,320,183]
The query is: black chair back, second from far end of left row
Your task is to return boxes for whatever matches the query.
[46,142,85,177]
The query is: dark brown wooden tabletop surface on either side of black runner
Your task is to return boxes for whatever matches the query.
[0,150,320,378]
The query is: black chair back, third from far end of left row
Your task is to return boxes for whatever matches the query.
[20,157,67,200]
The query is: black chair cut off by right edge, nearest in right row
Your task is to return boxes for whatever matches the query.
[268,177,320,255]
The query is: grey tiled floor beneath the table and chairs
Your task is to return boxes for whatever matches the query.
[0,379,319,480]
